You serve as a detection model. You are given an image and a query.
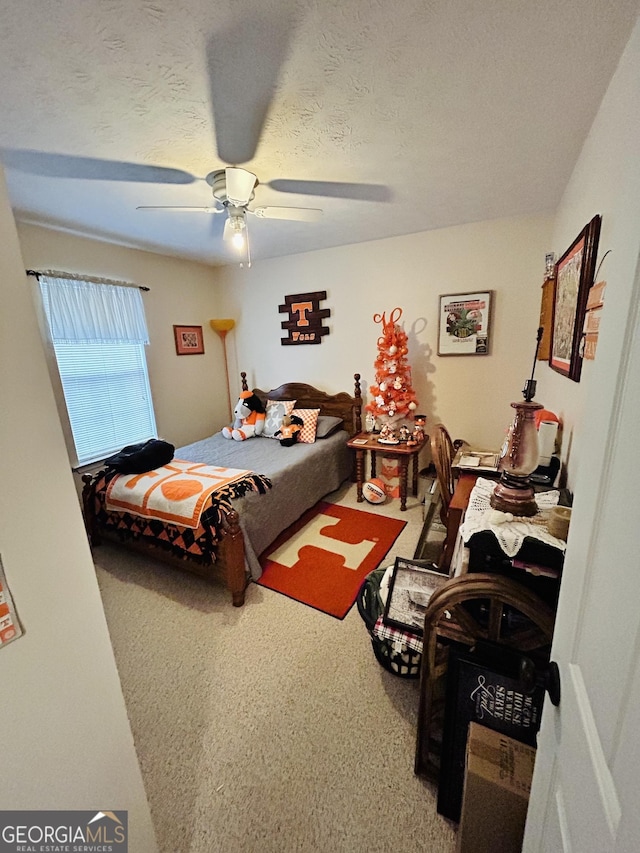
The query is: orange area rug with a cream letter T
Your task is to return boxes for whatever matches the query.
[258,501,406,619]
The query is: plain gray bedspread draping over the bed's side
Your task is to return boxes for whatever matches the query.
[175,430,352,580]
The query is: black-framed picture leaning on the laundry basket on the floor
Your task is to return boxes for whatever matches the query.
[382,557,449,637]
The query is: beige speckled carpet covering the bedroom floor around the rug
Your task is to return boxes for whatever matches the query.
[95,485,455,853]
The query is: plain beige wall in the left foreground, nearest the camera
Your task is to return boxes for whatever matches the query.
[0,172,156,851]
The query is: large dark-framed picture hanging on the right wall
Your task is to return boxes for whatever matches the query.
[549,216,601,382]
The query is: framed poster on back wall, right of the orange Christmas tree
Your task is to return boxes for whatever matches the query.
[438,290,493,355]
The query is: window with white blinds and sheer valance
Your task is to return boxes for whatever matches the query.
[39,275,156,465]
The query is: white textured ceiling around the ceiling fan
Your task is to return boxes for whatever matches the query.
[0,0,640,264]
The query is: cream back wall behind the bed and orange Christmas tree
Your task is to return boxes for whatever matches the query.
[220,211,552,447]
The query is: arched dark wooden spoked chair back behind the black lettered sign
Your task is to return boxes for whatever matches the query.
[414,572,555,779]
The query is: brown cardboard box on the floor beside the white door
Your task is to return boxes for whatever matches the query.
[456,723,536,853]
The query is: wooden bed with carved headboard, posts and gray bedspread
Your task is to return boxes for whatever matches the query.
[82,372,362,607]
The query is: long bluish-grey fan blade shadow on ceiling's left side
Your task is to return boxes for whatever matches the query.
[0,148,199,184]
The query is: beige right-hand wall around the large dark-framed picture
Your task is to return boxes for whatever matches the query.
[538,15,640,488]
